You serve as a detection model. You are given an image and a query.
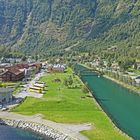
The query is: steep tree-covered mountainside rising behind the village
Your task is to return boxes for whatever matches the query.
[0,0,140,59]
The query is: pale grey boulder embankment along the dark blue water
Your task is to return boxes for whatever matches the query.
[0,119,75,140]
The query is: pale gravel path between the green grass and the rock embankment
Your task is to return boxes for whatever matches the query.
[0,112,92,140]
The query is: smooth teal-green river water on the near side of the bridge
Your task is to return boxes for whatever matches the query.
[75,64,140,140]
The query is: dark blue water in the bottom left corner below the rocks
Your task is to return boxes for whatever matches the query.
[0,125,50,140]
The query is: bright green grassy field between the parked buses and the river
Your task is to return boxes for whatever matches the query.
[13,69,128,140]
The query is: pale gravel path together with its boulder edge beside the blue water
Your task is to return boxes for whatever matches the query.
[0,112,92,140]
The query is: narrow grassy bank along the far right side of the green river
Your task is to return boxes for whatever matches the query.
[103,75,140,95]
